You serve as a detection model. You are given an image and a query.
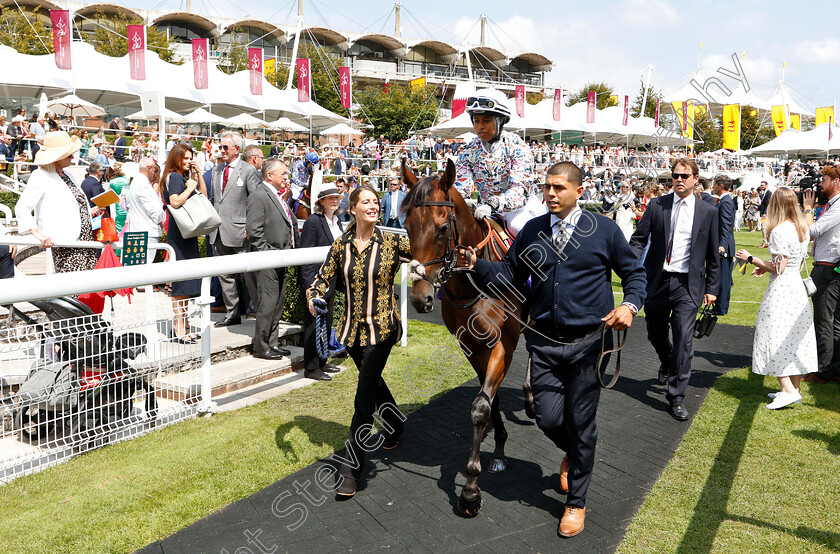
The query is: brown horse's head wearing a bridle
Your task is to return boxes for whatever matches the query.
[402,160,457,313]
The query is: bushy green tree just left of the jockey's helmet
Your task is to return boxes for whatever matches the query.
[356,83,438,141]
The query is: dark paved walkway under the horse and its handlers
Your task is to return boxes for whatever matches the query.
[139,315,752,554]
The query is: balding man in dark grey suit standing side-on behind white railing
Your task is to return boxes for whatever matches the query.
[246,158,298,360]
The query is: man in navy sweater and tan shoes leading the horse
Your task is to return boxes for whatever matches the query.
[459,162,645,537]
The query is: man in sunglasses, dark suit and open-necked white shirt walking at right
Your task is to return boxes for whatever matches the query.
[630,158,720,421]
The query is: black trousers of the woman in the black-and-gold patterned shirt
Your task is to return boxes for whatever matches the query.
[341,331,403,479]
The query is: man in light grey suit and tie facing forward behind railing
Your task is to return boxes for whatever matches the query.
[210,131,262,327]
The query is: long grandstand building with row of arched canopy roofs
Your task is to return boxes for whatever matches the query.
[0,0,552,109]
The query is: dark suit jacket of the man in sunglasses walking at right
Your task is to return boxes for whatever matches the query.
[630,193,720,306]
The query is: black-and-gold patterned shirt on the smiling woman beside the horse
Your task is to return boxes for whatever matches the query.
[308,225,411,346]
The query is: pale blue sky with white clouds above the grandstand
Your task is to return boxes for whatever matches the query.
[126,0,840,109]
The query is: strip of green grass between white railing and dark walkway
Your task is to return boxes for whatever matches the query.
[0,321,474,552]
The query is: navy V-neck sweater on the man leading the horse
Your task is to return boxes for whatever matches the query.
[475,210,645,328]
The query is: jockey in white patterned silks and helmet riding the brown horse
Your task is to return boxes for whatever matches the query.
[455,89,544,232]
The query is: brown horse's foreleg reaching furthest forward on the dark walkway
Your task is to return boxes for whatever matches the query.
[458,342,507,517]
